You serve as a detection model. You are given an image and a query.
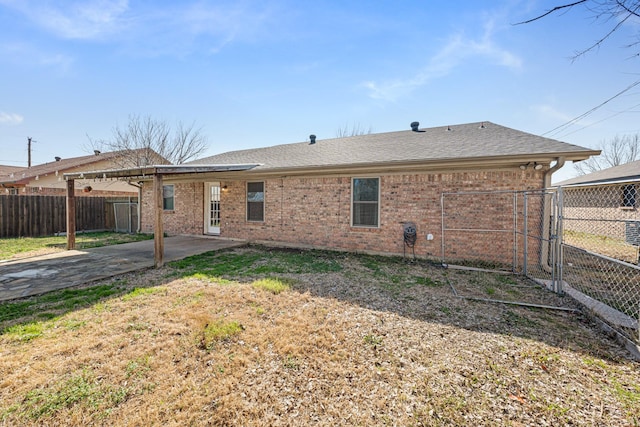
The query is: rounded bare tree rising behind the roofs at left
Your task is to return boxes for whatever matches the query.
[89,115,208,168]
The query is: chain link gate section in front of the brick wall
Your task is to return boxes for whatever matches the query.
[441,190,562,284]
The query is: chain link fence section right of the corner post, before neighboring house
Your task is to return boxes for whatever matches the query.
[558,182,640,344]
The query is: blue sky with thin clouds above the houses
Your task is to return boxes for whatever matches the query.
[0,0,640,178]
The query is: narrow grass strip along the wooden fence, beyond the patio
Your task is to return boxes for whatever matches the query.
[0,231,153,260]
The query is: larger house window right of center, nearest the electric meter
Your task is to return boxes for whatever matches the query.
[351,178,380,228]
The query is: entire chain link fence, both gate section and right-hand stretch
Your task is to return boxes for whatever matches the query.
[441,188,640,352]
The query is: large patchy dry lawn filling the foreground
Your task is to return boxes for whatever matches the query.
[0,247,640,426]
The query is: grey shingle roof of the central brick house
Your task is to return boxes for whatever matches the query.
[189,122,599,171]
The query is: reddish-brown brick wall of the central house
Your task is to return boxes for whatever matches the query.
[142,168,544,262]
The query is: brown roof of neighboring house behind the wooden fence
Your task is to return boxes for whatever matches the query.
[0,149,164,185]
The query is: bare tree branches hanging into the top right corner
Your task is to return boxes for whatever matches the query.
[516,0,640,60]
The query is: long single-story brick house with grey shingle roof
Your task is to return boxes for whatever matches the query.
[129,122,599,257]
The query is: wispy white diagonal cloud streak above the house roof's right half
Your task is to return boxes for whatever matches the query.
[363,15,522,101]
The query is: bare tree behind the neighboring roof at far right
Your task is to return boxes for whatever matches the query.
[573,133,640,175]
